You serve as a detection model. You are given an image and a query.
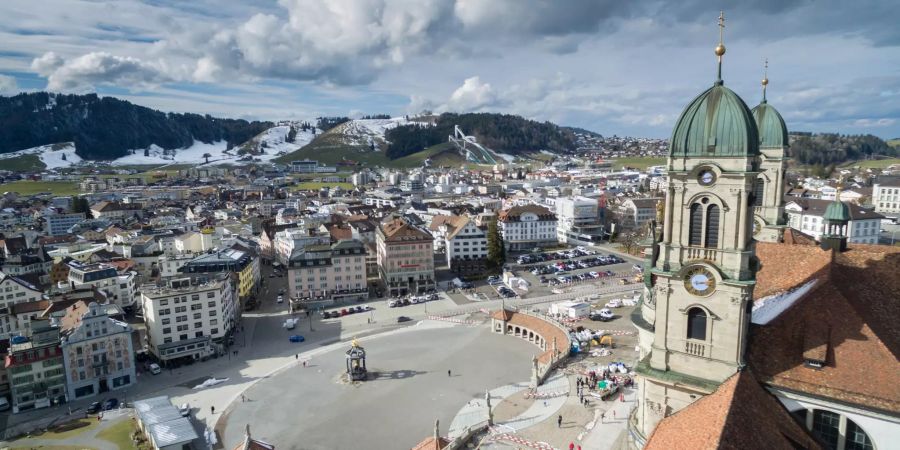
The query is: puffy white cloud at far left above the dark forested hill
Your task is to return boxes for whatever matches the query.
[31,52,173,91]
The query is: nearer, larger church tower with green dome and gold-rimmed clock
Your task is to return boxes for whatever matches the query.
[632,14,760,445]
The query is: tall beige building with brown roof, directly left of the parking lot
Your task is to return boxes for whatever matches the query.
[375,216,435,296]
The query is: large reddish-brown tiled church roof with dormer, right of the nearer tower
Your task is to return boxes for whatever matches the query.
[747,243,900,414]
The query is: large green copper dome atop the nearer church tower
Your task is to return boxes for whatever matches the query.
[669,81,759,158]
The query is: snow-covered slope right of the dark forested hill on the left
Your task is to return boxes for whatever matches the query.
[112,122,320,165]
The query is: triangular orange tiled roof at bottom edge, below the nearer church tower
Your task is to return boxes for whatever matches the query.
[644,369,821,450]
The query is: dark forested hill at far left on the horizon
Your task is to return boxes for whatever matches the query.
[0,92,273,160]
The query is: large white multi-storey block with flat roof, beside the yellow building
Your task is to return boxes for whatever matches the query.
[141,273,235,363]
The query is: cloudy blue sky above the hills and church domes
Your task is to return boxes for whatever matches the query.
[0,0,900,138]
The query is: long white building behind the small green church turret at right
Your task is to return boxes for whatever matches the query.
[784,198,884,244]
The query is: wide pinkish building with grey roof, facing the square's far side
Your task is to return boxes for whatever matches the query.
[287,239,369,302]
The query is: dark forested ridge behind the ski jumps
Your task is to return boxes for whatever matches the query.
[385,113,575,159]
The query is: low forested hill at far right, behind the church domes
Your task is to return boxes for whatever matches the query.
[788,133,898,166]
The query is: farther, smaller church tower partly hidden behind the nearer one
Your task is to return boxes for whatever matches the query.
[751,60,788,242]
